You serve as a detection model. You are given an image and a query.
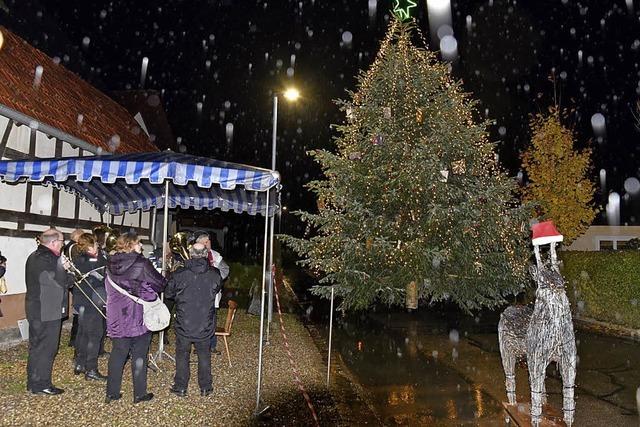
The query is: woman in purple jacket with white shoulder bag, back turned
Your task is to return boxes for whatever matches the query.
[105,233,166,403]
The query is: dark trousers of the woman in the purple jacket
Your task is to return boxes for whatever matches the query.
[107,332,151,397]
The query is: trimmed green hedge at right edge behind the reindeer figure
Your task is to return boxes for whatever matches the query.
[559,250,640,329]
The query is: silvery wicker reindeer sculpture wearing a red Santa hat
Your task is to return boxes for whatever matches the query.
[498,225,576,426]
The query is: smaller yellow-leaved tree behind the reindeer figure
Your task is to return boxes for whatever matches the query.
[522,107,598,244]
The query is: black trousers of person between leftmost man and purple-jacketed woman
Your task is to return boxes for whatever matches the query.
[76,305,104,371]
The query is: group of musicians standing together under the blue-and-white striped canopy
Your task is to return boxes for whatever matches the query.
[25,228,229,403]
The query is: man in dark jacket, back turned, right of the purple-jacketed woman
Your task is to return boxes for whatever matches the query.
[165,243,222,397]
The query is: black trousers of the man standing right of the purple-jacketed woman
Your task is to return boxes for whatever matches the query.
[173,334,212,390]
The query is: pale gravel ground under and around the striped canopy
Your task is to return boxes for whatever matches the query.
[0,309,344,426]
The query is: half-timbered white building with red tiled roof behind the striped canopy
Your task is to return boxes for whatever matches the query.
[0,26,158,335]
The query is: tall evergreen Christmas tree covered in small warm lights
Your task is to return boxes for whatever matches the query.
[283,19,528,310]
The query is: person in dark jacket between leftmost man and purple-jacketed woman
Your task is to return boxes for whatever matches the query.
[72,233,107,381]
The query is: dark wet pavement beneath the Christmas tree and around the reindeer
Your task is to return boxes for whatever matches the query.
[318,312,640,426]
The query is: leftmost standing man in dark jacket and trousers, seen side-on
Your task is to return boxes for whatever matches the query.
[25,228,73,395]
